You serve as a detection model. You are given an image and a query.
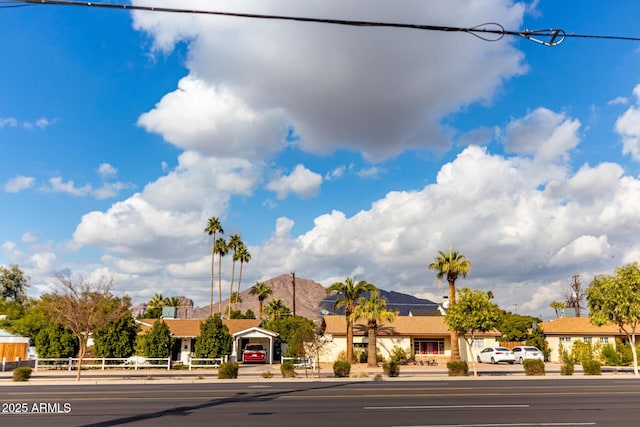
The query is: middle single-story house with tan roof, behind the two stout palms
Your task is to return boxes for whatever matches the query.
[320,315,500,363]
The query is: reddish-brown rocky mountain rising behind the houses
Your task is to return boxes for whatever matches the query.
[132,274,438,321]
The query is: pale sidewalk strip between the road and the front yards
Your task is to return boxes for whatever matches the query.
[0,363,635,385]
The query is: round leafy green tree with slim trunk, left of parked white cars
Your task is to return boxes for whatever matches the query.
[444,288,501,377]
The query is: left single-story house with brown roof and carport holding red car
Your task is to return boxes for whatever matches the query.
[136,319,278,363]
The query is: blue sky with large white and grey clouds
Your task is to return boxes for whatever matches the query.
[0,0,640,317]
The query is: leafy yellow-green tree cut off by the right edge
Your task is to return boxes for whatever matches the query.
[586,262,640,375]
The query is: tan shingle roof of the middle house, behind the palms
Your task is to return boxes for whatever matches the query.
[322,315,500,337]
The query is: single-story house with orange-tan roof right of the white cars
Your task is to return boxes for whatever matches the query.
[538,317,627,362]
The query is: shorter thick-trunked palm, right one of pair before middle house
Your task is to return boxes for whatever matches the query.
[351,290,397,367]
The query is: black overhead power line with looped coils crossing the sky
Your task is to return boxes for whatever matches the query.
[5,0,640,46]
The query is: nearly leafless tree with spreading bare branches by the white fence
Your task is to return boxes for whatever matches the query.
[42,275,130,381]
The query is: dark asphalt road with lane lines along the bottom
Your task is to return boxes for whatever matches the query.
[0,377,640,427]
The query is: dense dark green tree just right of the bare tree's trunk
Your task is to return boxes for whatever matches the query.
[92,313,138,357]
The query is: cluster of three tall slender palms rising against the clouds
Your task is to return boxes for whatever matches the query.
[204,216,251,316]
